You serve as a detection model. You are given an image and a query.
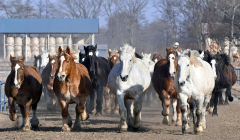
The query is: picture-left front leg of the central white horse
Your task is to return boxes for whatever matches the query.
[117,90,128,130]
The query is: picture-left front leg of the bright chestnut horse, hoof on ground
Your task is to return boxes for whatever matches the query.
[59,99,72,131]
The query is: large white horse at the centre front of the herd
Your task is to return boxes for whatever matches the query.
[108,44,151,130]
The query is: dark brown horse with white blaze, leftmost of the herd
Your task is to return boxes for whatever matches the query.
[5,55,42,131]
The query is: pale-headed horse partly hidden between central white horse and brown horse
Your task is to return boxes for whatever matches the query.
[142,53,156,106]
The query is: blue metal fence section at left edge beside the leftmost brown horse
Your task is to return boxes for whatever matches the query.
[0,82,8,112]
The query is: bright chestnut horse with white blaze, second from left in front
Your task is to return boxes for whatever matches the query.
[53,47,92,131]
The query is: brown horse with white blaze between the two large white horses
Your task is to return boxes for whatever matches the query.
[152,47,182,125]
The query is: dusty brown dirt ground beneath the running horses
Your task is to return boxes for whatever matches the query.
[0,85,240,140]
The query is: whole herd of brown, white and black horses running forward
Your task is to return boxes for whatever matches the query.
[5,44,237,134]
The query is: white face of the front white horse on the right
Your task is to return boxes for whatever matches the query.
[178,57,190,83]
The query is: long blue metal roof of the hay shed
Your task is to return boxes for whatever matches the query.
[0,19,99,34]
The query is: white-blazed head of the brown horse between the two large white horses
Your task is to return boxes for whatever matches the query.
[166,47,178,78]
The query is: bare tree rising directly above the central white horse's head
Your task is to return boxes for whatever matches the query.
[117,0,148,45]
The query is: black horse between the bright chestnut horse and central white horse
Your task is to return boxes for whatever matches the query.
[82,45,111,116]
